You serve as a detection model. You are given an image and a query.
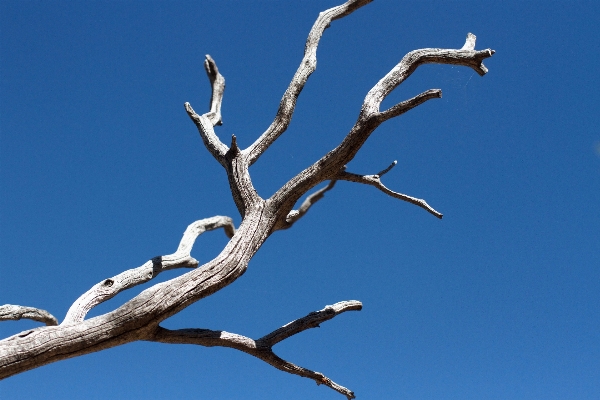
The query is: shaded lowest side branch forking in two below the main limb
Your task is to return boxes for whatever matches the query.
[146,300,362,399]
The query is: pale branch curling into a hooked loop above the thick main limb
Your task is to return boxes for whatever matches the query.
[61,216,235,325]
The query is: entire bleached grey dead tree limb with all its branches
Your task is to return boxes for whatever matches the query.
[0,0,494,398]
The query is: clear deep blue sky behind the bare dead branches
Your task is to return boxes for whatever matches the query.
[0,1,600,400]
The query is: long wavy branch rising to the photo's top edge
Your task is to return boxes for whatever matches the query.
[248,0,373,165]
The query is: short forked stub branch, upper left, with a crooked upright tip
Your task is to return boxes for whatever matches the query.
[184,54,229,166]
